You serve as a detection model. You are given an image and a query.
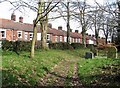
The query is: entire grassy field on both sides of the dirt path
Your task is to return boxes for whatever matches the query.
[2,49,120,87]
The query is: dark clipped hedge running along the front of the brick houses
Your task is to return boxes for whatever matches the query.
[2,40,92,51]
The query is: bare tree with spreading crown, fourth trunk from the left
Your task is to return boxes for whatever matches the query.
[74,0,90,47]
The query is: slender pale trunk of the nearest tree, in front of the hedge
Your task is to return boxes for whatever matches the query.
[30,24,37,58]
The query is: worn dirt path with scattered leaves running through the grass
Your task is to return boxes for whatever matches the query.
[39,59,82,88]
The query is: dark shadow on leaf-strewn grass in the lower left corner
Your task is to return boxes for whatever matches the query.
[2,69,34,88]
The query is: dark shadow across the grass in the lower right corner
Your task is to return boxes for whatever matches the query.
[80,64,120,88]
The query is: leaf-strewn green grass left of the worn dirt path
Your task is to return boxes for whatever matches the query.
[2,50,88,86]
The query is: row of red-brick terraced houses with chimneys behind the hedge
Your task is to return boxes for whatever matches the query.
[0,14,104,44]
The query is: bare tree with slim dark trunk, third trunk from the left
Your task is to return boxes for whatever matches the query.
[51,0,71,44]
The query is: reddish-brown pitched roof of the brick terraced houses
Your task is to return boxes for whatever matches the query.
[0,18,82,38]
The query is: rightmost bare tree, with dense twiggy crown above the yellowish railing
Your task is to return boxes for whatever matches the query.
[96,2,117,43]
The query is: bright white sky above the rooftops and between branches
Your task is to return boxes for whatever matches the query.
[0,0,116,34]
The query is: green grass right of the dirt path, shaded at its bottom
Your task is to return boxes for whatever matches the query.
[78,58,120,86]
